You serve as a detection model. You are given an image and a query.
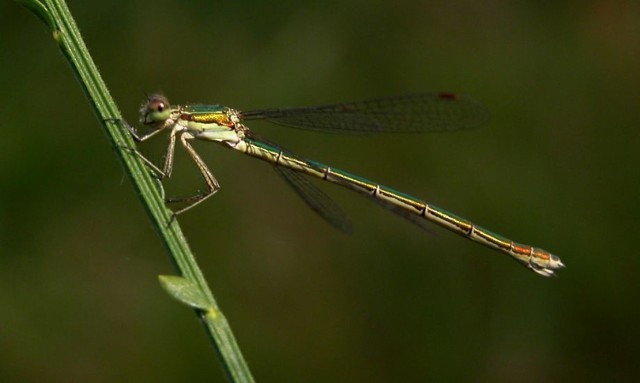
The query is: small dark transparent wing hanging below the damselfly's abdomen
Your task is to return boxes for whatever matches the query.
[275,166,353,234]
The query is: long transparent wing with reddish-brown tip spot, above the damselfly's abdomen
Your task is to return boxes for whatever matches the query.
[240,93,489,133]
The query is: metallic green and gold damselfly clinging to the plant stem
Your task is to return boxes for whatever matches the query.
[130,93,564,276]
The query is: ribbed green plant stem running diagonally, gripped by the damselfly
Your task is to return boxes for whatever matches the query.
[18,0,253,382]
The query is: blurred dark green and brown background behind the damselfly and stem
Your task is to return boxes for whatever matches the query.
[0,0,640,382]
